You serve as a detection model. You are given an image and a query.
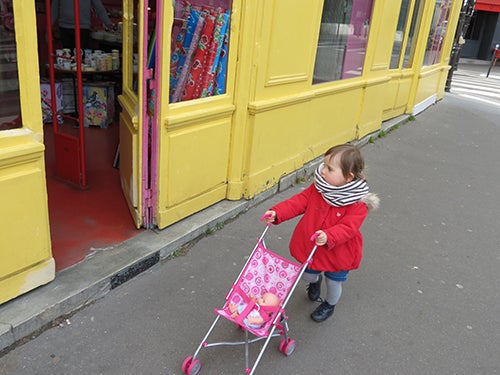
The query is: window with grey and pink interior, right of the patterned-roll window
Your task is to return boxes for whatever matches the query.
[313,0,373,83]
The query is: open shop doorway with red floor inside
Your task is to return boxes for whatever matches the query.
[36,0,141,271]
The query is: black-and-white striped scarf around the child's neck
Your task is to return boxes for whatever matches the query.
[314,163,369,207]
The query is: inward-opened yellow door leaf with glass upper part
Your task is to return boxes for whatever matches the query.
[118,0,154,228]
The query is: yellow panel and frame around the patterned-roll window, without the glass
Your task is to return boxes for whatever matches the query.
[156,0,239,228]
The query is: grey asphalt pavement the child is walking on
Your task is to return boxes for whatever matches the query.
[0,81,500,375]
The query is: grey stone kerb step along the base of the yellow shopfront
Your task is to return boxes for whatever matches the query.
[0,57,498,353]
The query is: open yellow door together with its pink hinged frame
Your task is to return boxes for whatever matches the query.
[118,0,156,228]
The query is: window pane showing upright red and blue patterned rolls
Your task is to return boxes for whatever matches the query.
[170,0,231,103]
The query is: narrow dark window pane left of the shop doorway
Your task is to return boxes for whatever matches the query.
[0,0,22,130]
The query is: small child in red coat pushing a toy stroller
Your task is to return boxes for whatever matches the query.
[265,144,379,322]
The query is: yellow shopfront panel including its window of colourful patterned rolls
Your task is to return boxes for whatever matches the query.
[151,0,236,229]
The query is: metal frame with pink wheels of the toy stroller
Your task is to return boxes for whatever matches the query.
[181,225,317,375]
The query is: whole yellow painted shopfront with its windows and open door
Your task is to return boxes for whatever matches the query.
[0,0,461,303]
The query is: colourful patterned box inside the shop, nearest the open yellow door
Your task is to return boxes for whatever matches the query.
[83,82,115,128]
